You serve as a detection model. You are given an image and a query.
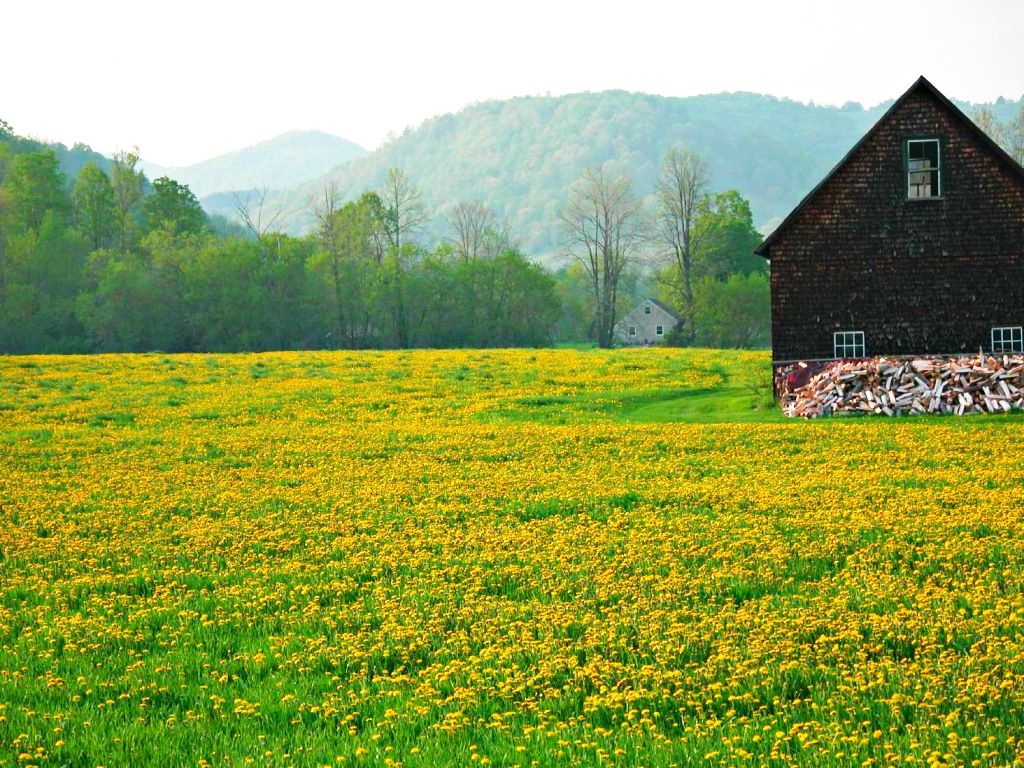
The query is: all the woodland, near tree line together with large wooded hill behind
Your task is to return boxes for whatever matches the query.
[0,93,1024,353]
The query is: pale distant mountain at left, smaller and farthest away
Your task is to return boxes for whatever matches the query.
[139,131,368,198]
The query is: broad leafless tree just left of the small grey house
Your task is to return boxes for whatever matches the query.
[561,168,644,348]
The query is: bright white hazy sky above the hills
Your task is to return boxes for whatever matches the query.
[6,0,1024,166]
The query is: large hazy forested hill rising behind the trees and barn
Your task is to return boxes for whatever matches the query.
[204,91,1017,255]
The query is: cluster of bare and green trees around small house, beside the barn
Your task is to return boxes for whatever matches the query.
[561,150,771,347]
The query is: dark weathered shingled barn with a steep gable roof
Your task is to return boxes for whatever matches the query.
[756,77,1024,380]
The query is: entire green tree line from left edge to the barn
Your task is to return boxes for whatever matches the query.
[0,123,768,353]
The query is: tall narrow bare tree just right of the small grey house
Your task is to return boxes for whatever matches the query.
[655,150,711,343]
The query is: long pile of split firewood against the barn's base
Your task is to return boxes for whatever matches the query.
[781,353,1024,419]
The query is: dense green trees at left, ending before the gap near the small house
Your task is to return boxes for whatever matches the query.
[0,137,559,352]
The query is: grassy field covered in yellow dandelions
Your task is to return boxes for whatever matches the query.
[0,349,1024,768]
